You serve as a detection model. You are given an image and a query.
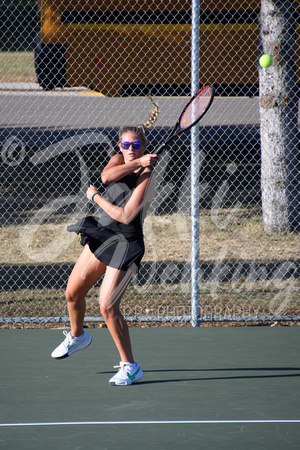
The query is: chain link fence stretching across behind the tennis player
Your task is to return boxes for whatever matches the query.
[0,0,300,323]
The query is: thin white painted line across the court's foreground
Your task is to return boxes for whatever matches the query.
[0,419,300,427]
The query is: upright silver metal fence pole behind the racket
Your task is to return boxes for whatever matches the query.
[191,0,200,327]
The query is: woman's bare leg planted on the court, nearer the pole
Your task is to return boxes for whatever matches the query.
[99,267,134,363]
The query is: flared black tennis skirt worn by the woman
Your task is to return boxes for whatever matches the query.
[67,216,145,272]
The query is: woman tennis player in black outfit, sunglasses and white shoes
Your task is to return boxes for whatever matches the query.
[51,119,158,386]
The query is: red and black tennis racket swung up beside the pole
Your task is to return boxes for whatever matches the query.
[154,86,215,155]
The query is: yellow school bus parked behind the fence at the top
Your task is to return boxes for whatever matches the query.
[35,0,298,96]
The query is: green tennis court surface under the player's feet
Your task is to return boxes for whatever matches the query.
[0,327,300,450]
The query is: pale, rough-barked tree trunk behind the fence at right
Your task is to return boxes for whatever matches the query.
[259,0,300,234]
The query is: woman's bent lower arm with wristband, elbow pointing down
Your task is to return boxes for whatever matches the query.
[87,168,155,224]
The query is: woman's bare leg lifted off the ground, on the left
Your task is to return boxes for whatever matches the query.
[66,245,106,337]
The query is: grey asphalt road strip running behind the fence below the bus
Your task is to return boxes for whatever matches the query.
[0,83,259,130]
